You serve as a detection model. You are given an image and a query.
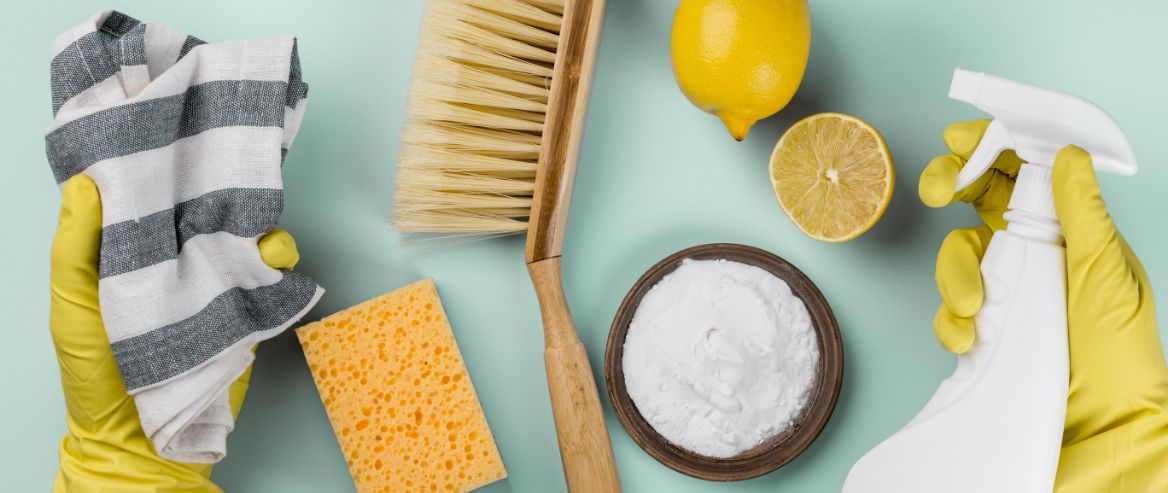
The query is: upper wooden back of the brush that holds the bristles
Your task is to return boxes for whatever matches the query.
[526,0,605,263]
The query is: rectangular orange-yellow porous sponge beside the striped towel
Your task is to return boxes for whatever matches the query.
[297,279,507,493]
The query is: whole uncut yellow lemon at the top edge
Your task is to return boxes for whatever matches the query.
[669,0,811,140]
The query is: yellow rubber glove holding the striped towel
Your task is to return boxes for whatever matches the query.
[49,175,299,493]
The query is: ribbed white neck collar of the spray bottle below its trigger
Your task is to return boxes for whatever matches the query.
[1003,164,1063,245]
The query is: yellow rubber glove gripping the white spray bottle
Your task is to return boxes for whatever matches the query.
[919,120,1168,493]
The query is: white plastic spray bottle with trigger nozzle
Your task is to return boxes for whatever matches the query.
[843,69,1136,493]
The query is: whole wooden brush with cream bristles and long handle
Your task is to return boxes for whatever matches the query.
[392,0,620,492]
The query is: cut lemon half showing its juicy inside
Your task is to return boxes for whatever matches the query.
[771,113,896,243]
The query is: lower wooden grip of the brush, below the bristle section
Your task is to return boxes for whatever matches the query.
[527,257,620,493]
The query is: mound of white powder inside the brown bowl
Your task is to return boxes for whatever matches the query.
[623,259,820,458]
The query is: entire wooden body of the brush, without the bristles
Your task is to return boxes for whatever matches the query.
[526,0,620,493]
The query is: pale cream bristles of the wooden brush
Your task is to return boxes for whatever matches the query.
[392,0,564,236]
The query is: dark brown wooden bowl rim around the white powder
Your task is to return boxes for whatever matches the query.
[604,243,843,481]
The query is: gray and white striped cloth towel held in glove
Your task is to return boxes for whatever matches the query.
[46,12,324,463]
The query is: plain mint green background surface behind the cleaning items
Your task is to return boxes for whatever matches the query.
[0,0,1168,493]
